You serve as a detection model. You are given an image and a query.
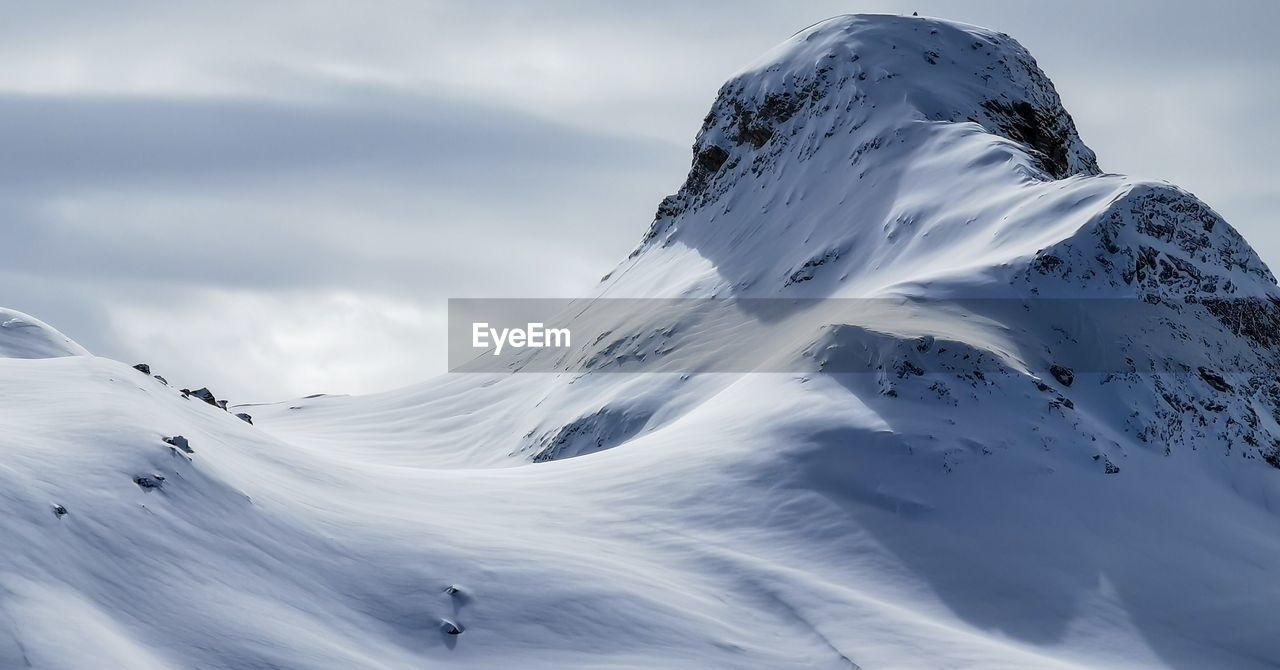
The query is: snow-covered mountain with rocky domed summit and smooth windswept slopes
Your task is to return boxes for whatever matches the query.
[0,15,1280,669]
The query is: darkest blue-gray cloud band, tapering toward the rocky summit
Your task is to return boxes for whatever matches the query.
[0,90,680,196]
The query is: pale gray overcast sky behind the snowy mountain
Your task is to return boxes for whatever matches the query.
[0,0,1280,401]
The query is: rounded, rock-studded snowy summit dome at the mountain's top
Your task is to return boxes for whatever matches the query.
[645,14,1101,260]
